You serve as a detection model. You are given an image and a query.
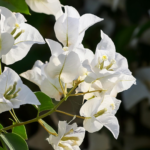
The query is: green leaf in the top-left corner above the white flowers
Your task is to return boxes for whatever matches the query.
[0,0,30,15]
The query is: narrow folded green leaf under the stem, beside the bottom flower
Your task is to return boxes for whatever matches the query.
[38,119,57,135]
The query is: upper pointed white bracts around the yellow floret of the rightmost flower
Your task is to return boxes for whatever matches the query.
[91,31,131,75]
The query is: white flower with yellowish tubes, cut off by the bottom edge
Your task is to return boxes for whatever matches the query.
[47,121,85,150]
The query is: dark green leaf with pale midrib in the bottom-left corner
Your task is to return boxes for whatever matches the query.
[0,133,29,150]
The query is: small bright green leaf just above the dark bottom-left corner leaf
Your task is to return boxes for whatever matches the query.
[12,125,28,140]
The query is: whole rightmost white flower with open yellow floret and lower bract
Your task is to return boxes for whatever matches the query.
[85,32,135,95]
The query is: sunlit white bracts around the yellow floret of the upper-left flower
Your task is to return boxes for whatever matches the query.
[0,7,45,65]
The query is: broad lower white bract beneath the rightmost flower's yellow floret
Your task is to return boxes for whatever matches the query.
[85,70,136,97]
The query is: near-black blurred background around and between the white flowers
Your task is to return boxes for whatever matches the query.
[0,0,150,150]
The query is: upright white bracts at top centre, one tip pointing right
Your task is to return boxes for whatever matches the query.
[54,6,103,49]
